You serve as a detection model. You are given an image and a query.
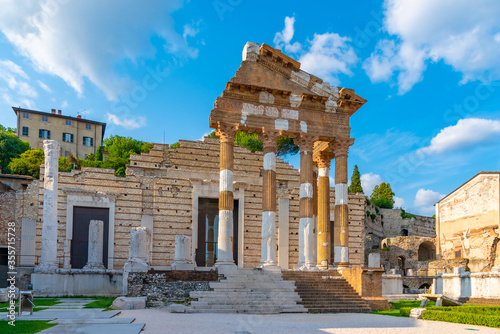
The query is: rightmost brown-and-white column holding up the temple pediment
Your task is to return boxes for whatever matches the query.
[333,138,354,268]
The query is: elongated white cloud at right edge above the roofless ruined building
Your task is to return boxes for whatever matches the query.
[417,118,500,154]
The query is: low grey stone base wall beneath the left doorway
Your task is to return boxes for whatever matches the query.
[31,269,123,297]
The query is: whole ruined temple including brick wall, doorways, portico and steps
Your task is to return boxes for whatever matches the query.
[27,43,387,312]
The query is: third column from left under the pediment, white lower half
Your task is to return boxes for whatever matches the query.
[297,134,317,270]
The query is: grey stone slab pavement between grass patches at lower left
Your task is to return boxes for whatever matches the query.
[17,298,144,334]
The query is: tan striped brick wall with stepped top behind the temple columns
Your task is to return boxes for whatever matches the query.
[31,138,364,269]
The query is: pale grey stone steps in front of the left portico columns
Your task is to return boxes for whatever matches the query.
[187,269,307,314]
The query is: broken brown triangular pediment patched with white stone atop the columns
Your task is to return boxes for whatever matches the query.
[210,43,366,141]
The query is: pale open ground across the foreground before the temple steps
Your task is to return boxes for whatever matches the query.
[117,309,500,334]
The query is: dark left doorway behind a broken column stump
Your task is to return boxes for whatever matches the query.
[71,206,109,269]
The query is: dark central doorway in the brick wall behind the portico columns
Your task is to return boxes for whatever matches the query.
[195,198,238,267]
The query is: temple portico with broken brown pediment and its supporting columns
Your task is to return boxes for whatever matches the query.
[210,43,366,269]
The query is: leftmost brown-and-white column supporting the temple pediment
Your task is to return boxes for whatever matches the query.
[215,122,237,267]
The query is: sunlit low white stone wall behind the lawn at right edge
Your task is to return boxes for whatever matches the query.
[433,267,500,299]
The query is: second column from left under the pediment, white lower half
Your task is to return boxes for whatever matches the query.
[259,130,279,270]
